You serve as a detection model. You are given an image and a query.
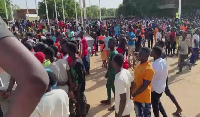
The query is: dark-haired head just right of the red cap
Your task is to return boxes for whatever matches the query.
[44,47,55,62]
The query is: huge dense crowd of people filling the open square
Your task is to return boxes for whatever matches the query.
[0,15,200,117]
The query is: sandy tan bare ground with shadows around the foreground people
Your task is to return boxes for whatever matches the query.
[86,54,200,117]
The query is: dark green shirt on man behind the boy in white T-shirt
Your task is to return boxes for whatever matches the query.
[108,50,118,78]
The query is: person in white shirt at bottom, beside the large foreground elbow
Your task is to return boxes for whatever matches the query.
[30,70,69,117]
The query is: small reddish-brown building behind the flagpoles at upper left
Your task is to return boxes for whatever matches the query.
[14,9,36,20]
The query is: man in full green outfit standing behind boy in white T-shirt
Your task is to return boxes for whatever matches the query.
[101,38,118,104]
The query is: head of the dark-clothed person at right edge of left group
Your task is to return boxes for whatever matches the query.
[66,42,78,57]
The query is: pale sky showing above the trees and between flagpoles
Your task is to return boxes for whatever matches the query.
[11,0,123,9]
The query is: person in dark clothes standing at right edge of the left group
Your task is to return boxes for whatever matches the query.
[66,43,90,117]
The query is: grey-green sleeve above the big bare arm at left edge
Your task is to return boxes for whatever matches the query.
[0,18,14,39]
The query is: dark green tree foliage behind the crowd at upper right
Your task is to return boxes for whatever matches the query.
[117,0,200,17]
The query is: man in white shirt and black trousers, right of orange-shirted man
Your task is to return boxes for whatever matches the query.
[151,46,168,117]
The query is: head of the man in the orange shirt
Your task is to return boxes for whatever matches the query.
[138,47,150,63]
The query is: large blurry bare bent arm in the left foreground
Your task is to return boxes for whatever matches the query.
[0,37,49,117]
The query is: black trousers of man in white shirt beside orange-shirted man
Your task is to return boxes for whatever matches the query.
[151,91,167,117]
